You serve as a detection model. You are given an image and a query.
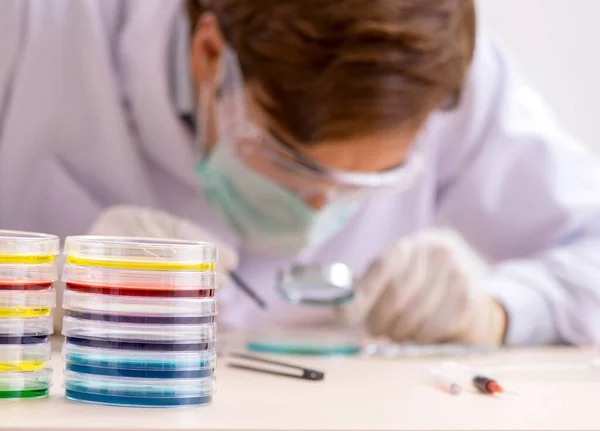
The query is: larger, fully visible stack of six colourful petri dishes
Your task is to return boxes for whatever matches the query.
[62,236,217,407]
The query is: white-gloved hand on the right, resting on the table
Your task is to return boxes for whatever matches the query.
[336,231,507,344]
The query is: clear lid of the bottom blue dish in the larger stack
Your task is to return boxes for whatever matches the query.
[64,371,215,399]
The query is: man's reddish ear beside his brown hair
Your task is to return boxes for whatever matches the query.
[191,13,225,86]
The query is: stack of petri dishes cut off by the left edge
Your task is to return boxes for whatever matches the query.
[0,230,60,400]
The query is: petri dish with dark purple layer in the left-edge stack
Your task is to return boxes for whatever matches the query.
[0,316,54,349]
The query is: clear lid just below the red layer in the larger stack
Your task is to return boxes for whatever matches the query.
[63,290,217,317]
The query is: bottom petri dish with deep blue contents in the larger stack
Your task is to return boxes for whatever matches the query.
[65,371,215,408]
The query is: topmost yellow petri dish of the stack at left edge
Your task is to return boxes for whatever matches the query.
[0,230,60,265]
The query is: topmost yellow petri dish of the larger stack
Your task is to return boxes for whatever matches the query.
[64,236,218,271]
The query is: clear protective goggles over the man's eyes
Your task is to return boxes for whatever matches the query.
[200,49,423,207]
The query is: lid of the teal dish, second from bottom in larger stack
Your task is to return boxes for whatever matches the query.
[62,343,217,370]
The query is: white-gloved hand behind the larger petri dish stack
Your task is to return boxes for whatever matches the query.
[88,205,238,287]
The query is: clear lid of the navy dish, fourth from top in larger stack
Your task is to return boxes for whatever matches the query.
[62,317,216,344]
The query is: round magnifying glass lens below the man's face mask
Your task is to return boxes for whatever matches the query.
[277,263,354,306]
